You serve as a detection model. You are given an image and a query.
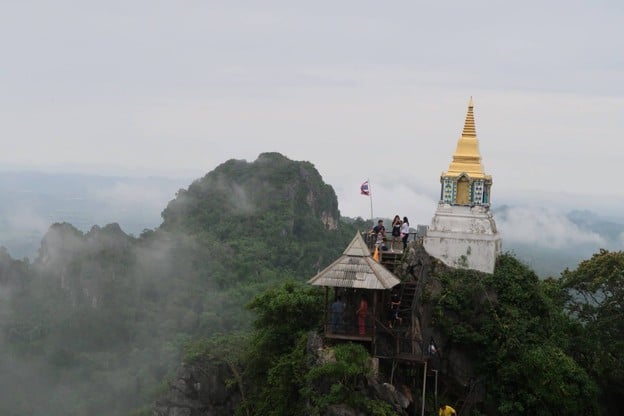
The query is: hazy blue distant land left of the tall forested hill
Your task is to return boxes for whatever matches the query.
[0,172,192,258]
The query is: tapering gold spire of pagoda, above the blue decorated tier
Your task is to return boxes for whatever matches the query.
[442,97,488,179]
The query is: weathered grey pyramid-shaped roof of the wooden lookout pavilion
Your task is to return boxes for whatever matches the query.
[308,233,401,289]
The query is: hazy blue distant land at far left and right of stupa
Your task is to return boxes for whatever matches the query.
[0,172,624,277]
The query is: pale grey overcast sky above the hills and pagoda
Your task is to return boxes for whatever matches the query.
[0,0,624,228]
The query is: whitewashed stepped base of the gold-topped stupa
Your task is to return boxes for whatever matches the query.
[423,204,503,273]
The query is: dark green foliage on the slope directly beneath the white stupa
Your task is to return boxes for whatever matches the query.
[436,254,596,415]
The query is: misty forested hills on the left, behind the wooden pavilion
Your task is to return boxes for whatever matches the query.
[0,153,369,415]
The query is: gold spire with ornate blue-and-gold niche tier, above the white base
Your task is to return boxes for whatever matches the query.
[440,97,492,206]
